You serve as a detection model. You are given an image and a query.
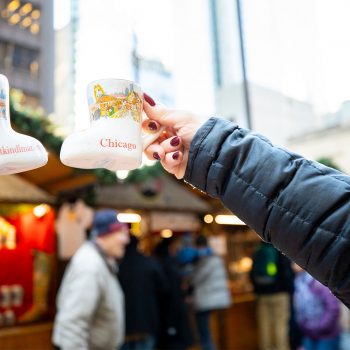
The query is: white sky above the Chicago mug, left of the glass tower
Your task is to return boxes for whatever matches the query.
[55,0,214,129]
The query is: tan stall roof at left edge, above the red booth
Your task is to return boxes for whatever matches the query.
[0,175,55,204]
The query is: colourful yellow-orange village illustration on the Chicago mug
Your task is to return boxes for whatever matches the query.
[90,84,142,123]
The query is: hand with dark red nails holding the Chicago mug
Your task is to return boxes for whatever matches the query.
[143,94,203,179]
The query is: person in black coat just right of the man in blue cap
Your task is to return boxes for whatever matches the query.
[118,236,168,350]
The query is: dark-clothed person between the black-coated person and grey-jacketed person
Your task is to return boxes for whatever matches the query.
[154,238,193,350]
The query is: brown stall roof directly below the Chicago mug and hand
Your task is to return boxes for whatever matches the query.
[96,174,211,213]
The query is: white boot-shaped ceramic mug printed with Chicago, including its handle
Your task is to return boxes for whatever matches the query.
[60,79,163,171]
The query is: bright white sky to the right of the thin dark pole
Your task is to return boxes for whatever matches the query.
[244,0,350,113]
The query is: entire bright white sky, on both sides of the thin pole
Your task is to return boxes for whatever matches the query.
[55,0,350,126]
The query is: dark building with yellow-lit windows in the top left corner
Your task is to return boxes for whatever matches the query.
[0,0,54,113]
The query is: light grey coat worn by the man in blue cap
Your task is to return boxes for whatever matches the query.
[53,242,124,350]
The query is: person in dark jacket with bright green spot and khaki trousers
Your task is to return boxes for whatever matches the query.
[250,241,294,350]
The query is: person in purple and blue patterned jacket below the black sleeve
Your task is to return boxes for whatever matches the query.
[293,264,340,350]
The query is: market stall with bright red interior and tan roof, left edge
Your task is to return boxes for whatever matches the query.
[0,175,56,349]
